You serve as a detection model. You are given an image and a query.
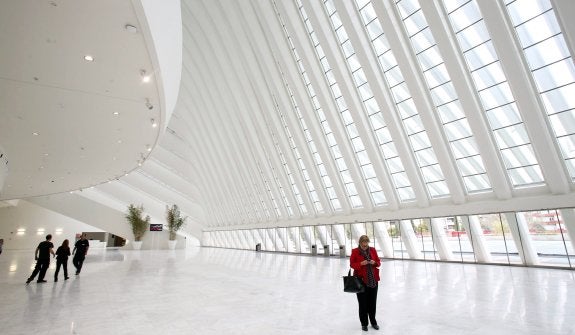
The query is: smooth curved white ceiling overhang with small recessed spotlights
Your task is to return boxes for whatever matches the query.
[0,1,165,199]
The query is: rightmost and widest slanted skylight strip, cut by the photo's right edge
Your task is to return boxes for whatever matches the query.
[505,0,575,181]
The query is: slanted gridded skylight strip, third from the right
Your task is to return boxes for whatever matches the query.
[397,0,491,193]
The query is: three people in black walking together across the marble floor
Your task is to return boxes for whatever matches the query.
[26,234,90,285]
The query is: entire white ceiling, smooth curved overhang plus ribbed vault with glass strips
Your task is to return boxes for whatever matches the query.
[0,0,575,242]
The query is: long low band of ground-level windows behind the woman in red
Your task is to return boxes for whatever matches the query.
[204,208,575,269]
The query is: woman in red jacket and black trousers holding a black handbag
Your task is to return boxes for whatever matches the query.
[349,235,381,331]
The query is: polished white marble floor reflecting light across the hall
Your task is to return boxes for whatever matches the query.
[0,248,575,335]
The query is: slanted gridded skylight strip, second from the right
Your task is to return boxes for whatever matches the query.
[443,0,543,187]
